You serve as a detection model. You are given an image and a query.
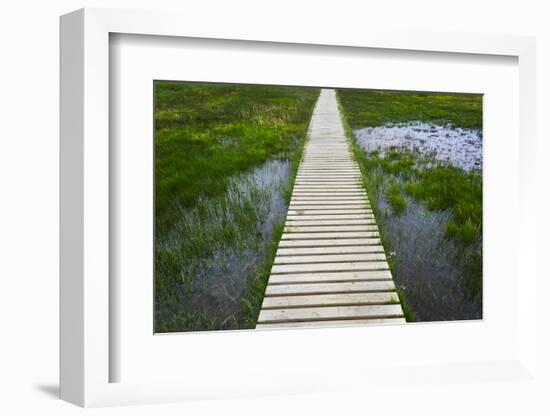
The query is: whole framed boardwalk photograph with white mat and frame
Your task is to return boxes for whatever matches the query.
[61,9,536,406]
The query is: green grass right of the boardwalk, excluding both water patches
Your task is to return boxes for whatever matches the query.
[338,90,482,321]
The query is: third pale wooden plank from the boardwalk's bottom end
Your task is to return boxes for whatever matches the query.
[262,292,399,309]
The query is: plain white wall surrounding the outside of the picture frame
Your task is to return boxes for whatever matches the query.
[0,0,550,415]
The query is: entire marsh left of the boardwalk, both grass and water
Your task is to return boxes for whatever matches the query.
[155,81,319,332]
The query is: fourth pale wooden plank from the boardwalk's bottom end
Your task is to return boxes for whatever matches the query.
[265,280,395,296]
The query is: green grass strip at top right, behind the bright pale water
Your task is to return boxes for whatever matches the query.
[338,89,482,129]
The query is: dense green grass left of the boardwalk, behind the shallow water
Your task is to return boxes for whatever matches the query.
[154,81,319,232]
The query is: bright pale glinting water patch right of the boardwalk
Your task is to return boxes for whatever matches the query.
[354,121,483,171]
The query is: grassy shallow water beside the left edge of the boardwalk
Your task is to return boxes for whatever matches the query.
[156,160,291,330]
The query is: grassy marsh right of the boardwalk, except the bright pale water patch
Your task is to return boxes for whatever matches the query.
[338,90,482,321]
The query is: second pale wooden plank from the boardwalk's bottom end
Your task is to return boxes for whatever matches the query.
[258,305,403,323]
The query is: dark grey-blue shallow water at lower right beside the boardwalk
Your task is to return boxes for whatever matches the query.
[378,197,482,321]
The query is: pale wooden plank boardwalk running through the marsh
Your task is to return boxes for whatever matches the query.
[256,89,405,329]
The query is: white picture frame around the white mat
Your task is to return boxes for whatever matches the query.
[60,9,537,407]
